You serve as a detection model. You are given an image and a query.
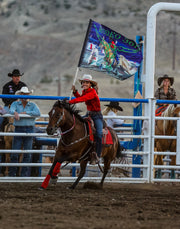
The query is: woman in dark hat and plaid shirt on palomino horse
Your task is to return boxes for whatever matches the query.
[154,74,176,116]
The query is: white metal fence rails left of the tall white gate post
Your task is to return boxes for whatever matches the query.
[0,115,149,183]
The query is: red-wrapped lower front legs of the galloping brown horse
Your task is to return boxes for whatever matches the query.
[40,160,62,189]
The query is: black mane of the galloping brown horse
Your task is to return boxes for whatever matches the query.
[53,99,85,122]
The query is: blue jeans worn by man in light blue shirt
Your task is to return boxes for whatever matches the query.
[9,126,34,177]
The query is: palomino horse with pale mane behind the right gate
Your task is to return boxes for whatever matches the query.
[154,104,180,178]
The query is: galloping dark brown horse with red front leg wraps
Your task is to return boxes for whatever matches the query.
[40,100,122,189]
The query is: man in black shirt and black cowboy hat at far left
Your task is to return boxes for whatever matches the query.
[0,69,26,131]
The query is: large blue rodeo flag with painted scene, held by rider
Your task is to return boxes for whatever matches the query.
[78,19,142,80]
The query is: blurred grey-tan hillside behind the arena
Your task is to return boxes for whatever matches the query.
[0,0,180,112]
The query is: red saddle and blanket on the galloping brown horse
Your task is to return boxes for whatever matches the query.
[85,117,113,146]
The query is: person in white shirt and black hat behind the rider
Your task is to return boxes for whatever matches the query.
[103,101,124,128]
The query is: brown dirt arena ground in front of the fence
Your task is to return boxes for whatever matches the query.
[0,183,180,229]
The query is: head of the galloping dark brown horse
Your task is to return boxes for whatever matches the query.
[46,100,65,135]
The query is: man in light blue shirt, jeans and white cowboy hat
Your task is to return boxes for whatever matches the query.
[9,87,41,176]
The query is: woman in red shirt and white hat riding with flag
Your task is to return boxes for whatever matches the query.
[69,74,103,164]
